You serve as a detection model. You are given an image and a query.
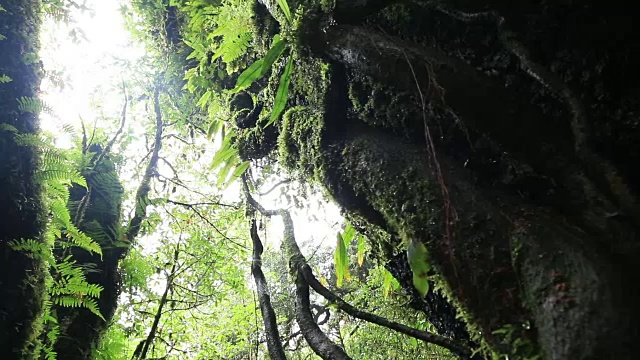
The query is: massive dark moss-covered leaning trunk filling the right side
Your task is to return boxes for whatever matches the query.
[239,1,640,359]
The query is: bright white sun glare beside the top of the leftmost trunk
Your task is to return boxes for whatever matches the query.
[40,0,144,147]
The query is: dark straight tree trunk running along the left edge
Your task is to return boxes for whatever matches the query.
[0,0,47,360]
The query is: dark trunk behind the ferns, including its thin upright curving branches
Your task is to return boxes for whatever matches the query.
[55,83,164,360]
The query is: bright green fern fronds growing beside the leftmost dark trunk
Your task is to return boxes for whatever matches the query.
[9,132,103,359]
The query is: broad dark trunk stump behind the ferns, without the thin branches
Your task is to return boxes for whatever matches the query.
[52,145,128,360]
